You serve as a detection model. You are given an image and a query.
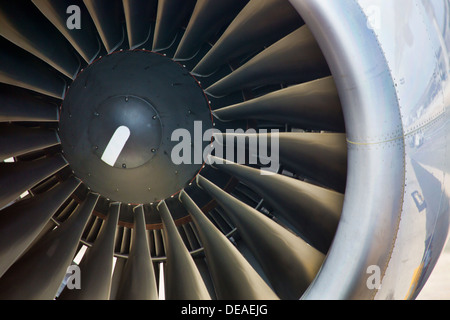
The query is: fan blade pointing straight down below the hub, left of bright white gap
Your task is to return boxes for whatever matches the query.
[116,205,158,300]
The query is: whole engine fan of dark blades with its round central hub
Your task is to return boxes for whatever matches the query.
[0,0,448,300]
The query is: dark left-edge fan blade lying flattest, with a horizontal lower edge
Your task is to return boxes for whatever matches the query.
[0,85,59,122]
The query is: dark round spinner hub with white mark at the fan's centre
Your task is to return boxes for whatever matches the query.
[59,50,212,204]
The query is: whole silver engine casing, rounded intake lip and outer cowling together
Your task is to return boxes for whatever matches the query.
[291,0,450,299]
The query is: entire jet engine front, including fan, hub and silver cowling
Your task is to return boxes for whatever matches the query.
[0,0,450,299]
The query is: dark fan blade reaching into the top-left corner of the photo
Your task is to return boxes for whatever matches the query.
[0,1,80,79]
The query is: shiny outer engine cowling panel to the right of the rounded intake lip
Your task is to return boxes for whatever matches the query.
[358,0,450,299]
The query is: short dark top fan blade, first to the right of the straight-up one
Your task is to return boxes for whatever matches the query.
[153,0,195,51]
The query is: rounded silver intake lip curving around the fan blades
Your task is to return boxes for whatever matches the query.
[290,0,405,299]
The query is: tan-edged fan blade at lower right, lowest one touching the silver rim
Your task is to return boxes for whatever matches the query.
[197,175,325,299]
